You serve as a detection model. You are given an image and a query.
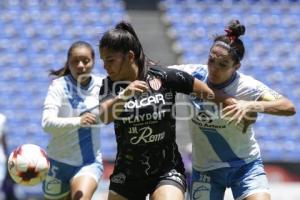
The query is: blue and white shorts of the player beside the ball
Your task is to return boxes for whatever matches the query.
[43,159,103,199]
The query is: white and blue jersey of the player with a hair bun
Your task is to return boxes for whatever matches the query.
[170,65,282,171]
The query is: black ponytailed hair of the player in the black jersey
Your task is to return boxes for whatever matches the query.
[99,21,154,79]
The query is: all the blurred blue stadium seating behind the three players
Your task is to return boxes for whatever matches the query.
[0,0,300,199]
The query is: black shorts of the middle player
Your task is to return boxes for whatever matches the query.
[109,169,186,200]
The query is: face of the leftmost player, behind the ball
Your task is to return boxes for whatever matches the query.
[68,46,94,85]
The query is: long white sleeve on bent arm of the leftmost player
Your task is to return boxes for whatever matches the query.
[42,81,80,134]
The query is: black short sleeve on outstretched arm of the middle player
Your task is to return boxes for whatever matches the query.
[166,69,194,94]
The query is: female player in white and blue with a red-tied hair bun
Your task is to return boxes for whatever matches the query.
[171,20,296,200]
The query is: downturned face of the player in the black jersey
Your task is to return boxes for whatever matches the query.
[100,48,129,81]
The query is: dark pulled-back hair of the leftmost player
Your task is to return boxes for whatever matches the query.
[49,41,95,77]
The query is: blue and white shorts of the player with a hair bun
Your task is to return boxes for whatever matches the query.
[190,160,269,200]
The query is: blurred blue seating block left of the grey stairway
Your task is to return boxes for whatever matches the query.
[0,0,127,159]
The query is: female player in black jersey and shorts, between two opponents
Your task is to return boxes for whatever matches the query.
[99,22,234,200]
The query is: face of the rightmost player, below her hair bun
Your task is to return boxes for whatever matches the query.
[207,46,240,84]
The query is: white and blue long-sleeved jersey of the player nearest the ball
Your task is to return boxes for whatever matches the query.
[42,75,102,166]
